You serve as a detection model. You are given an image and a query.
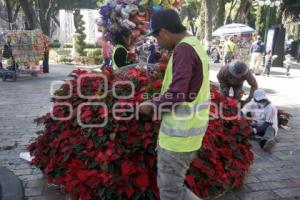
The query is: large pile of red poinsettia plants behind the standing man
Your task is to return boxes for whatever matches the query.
[29,64,253,200]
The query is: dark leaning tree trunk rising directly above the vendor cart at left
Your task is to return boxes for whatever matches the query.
[19,0,39,30]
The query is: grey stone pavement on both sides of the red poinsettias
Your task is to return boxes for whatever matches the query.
[0,65,300,200]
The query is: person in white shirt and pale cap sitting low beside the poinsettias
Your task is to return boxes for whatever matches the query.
[242,89,278,151]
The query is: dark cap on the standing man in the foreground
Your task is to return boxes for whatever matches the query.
[146,9,183,36]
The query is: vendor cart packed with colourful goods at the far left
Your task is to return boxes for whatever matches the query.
[0,31,45,81]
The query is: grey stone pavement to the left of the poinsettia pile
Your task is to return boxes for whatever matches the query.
[0,66,73,200]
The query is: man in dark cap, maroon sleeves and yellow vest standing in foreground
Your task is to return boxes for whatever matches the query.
[140,9,210,200]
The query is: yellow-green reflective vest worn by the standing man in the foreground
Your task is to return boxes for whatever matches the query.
[158,36,210,152]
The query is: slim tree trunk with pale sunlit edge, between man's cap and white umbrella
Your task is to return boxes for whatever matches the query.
[205,0,215,47]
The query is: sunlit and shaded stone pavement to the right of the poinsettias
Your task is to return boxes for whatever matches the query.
[211,65,300,200]
